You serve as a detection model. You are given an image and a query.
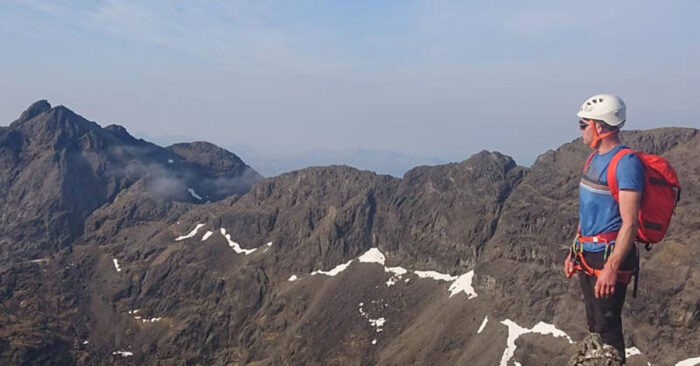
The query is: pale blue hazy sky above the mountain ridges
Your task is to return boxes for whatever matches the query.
[0,0,700,164]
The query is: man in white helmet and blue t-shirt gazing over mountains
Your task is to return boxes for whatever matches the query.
[564,94,644,364]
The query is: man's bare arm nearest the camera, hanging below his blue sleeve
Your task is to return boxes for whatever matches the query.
[595,190,642,298]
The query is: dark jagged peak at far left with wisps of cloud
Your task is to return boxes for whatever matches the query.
[0,100,261,260]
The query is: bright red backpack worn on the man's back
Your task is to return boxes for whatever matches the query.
[607,148,681,248]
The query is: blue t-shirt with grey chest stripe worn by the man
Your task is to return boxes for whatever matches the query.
[578,145,644,252]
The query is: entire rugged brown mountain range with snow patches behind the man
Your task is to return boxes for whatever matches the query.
[0,101,700,365]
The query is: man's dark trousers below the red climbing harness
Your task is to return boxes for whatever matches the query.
[578,248,636,363]
